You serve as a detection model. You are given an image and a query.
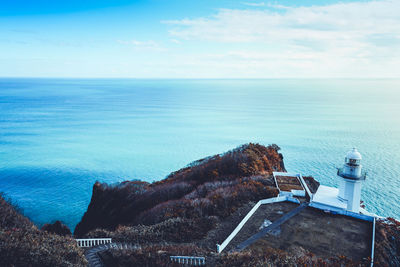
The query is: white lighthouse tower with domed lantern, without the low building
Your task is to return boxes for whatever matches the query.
[337,148,366,213]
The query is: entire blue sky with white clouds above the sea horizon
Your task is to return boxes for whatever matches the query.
[0,0,400,78]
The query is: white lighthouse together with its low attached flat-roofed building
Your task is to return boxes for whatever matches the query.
[310,148,366,216]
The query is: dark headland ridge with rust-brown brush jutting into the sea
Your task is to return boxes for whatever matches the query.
[75,143,285,236]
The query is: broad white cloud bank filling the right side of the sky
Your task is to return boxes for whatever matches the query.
[164,0,400,77]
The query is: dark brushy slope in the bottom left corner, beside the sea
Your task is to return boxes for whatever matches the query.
[0,195,87,266]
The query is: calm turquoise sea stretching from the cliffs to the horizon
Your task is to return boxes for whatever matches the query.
[0,79,400,228]
